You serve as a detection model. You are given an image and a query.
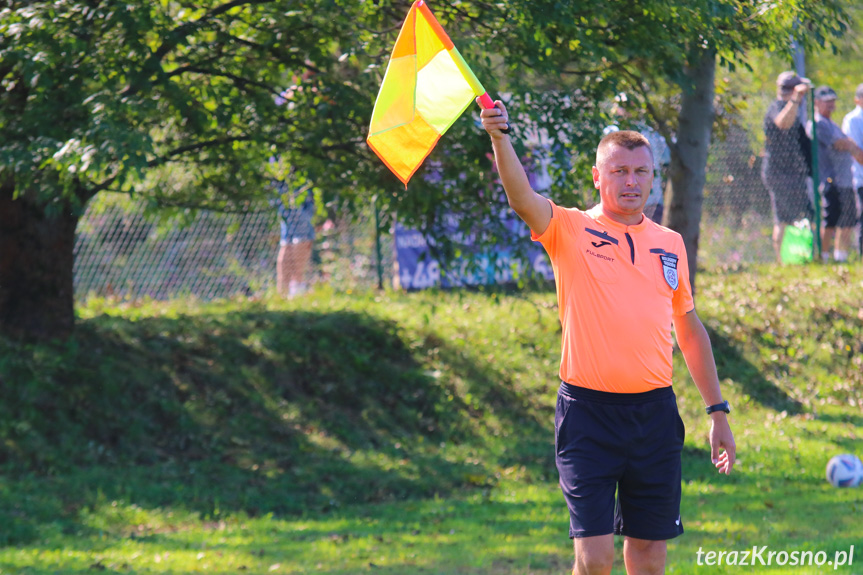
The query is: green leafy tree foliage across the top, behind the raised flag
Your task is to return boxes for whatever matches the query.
[0,0,845,340]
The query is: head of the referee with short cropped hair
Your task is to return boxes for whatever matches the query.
[593,144,653,216]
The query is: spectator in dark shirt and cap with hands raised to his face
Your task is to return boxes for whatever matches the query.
[761,72,812,263]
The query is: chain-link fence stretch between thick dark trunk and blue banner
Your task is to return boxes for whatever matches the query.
[75,202,393,299]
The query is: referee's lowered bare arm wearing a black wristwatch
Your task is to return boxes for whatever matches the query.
[674,310,737,475]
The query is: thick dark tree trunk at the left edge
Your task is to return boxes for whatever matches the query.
[0,183,79,340]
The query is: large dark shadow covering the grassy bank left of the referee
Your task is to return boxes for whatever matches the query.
[0,310,551,544]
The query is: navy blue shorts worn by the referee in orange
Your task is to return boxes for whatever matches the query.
[554,382,685,541]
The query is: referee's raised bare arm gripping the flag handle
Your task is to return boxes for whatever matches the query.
[477,98,551,234]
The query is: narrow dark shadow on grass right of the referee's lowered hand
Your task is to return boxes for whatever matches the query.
[705,326,803,415]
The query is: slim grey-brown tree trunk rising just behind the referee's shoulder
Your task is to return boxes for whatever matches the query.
[662,47,716,292]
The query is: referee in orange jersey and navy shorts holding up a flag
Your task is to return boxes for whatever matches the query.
[481,102,735,575]
